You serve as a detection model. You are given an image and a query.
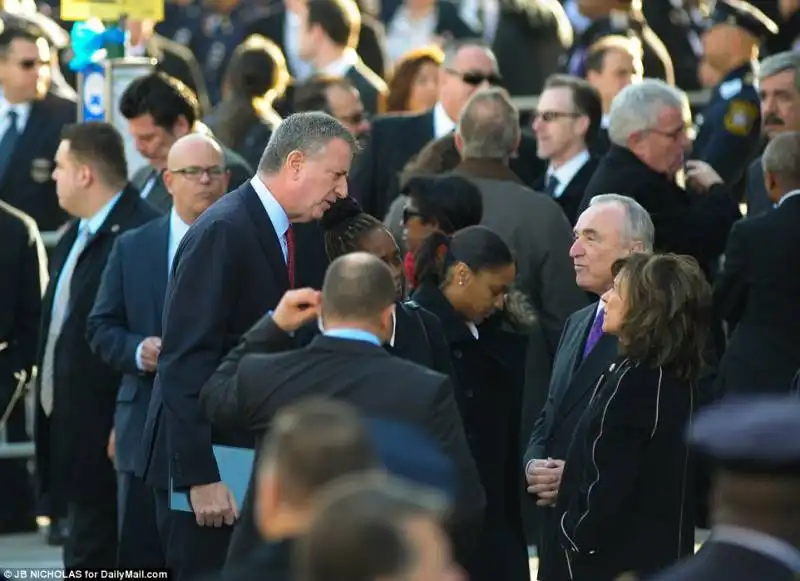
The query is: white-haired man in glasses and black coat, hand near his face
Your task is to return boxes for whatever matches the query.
[582,79,741,272]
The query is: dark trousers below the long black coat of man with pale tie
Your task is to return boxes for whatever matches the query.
[64,495,117,569]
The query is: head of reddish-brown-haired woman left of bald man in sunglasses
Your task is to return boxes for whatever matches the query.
[386,46,444,113]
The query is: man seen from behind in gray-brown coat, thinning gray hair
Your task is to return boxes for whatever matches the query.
[455,88,586,359]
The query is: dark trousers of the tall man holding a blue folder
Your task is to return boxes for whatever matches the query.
[155,488,233,581]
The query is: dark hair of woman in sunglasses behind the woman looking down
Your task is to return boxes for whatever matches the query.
[403,175,483,234]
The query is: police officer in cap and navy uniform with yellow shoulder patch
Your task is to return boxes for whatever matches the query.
[692,0,778,191]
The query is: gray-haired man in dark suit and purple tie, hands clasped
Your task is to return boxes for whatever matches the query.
[524,194,654,581]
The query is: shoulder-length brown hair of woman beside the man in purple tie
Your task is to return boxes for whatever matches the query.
[611,253,712,382]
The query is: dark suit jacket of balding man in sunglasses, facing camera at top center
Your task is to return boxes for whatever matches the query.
[350,110,544,220]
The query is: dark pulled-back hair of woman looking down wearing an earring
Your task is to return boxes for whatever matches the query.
[414,226,514,286]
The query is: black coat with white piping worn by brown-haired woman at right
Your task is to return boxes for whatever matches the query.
[552,357,698,581]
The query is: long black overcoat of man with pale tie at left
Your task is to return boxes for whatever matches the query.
[35,186,158,502]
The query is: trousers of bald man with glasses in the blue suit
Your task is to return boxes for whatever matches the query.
[117,472,166,568]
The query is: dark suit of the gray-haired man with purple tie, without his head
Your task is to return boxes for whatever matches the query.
[523,303,617,580]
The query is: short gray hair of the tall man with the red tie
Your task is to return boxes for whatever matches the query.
[258,111,358,175]
